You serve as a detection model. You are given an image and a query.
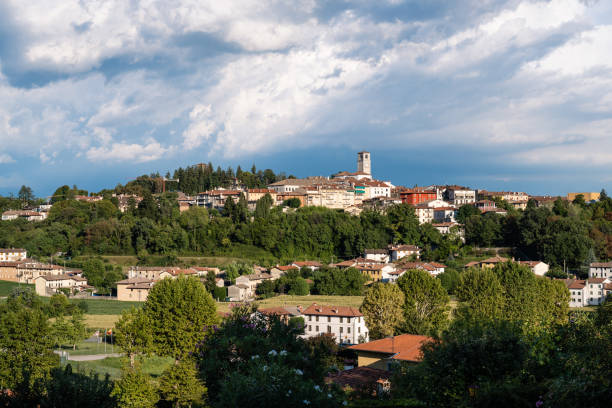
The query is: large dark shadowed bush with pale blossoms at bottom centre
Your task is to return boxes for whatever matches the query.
[196,306,338,407]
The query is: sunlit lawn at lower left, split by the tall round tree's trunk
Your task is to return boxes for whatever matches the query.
[64,356,174,380]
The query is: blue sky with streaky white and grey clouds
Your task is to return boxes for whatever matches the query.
[0,0,612,196]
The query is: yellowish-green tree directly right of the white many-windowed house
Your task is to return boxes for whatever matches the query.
[359,283,404,340]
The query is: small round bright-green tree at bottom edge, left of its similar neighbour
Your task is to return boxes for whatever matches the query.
[111,368,159,408]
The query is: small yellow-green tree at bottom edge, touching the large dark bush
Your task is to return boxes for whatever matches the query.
[159,359,206,408]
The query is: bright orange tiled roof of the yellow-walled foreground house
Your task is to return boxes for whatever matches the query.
[349,334,433,362]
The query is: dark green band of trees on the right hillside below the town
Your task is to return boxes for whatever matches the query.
[459,190,612,269]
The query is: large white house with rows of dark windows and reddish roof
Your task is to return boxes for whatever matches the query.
[303,303,369,344]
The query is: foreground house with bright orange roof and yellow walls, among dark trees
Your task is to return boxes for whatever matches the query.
[349,334,433,371]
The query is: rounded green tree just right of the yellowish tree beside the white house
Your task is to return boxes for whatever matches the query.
[397,270,450,335]
